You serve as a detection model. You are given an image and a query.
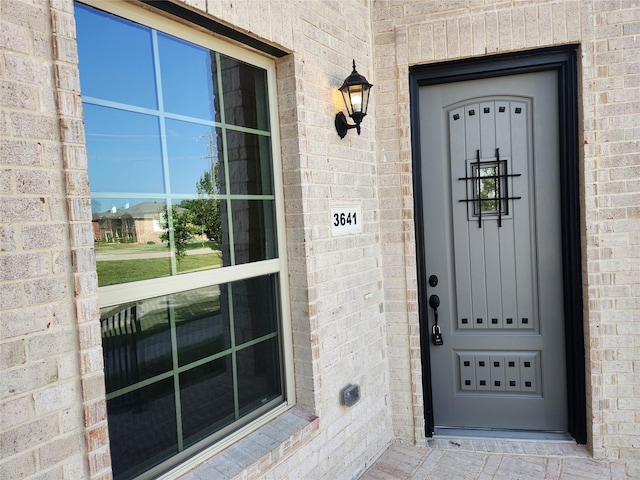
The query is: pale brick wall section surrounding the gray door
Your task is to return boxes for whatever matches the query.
[372,0,640,458]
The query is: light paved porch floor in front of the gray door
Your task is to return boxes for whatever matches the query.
[359,437,640,480]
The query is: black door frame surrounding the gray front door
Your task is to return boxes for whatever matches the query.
[409,45,587,444]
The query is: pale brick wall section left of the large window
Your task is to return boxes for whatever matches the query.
[0,0,99,478]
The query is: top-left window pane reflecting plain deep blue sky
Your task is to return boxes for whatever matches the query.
[75,4,157,108]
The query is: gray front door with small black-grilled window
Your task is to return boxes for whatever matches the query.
[420,71,567,431]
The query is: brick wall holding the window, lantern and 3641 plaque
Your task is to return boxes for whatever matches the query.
[0,0,392,478]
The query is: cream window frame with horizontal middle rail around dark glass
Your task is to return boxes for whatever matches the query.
[81,0,296,479]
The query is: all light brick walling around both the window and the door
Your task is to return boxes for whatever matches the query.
[0,0,640,478]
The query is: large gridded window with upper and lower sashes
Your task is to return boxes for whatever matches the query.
[75,3,287,479]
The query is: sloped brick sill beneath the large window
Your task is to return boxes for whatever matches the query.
[172,407,319,480]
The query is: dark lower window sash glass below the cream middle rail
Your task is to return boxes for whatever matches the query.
[100,274,283,478]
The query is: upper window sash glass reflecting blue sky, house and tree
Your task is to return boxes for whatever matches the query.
[77,5,277,286]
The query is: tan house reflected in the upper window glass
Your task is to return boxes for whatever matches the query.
[93,202,164,243]
